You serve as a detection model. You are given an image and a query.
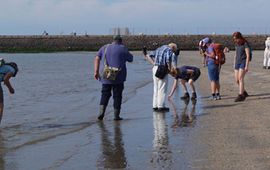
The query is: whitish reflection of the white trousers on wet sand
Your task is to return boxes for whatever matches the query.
[151,112,172,169]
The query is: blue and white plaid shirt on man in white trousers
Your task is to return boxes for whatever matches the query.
[150,45,177,67]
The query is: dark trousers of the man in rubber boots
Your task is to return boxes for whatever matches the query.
[100,83,124,110]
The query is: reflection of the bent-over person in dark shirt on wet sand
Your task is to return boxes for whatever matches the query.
[169,100,197,128]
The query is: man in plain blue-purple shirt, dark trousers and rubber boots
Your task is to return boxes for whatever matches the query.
[94,35,133,120]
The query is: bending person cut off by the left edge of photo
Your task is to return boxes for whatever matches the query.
[0,59,18,123]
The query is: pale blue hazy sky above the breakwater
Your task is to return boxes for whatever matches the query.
[0,0,270,35]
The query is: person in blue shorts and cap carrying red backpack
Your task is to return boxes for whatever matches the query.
[201,37,221,100]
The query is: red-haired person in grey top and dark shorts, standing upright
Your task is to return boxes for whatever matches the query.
[233,32,252,102]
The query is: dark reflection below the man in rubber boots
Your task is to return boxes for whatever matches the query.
[97,122,127,169]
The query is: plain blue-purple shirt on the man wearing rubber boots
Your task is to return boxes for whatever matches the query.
[97,42,133,84]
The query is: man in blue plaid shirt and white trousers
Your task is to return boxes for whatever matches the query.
[143,43,179,111]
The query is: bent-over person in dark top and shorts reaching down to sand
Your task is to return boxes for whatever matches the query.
[168,66,201,100]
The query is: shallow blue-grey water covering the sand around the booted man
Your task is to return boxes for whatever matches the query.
[0,52,203,170]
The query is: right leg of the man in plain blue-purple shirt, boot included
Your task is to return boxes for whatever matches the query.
[113,83,124,120]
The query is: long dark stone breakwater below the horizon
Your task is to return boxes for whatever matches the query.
[0,35,268,52]
